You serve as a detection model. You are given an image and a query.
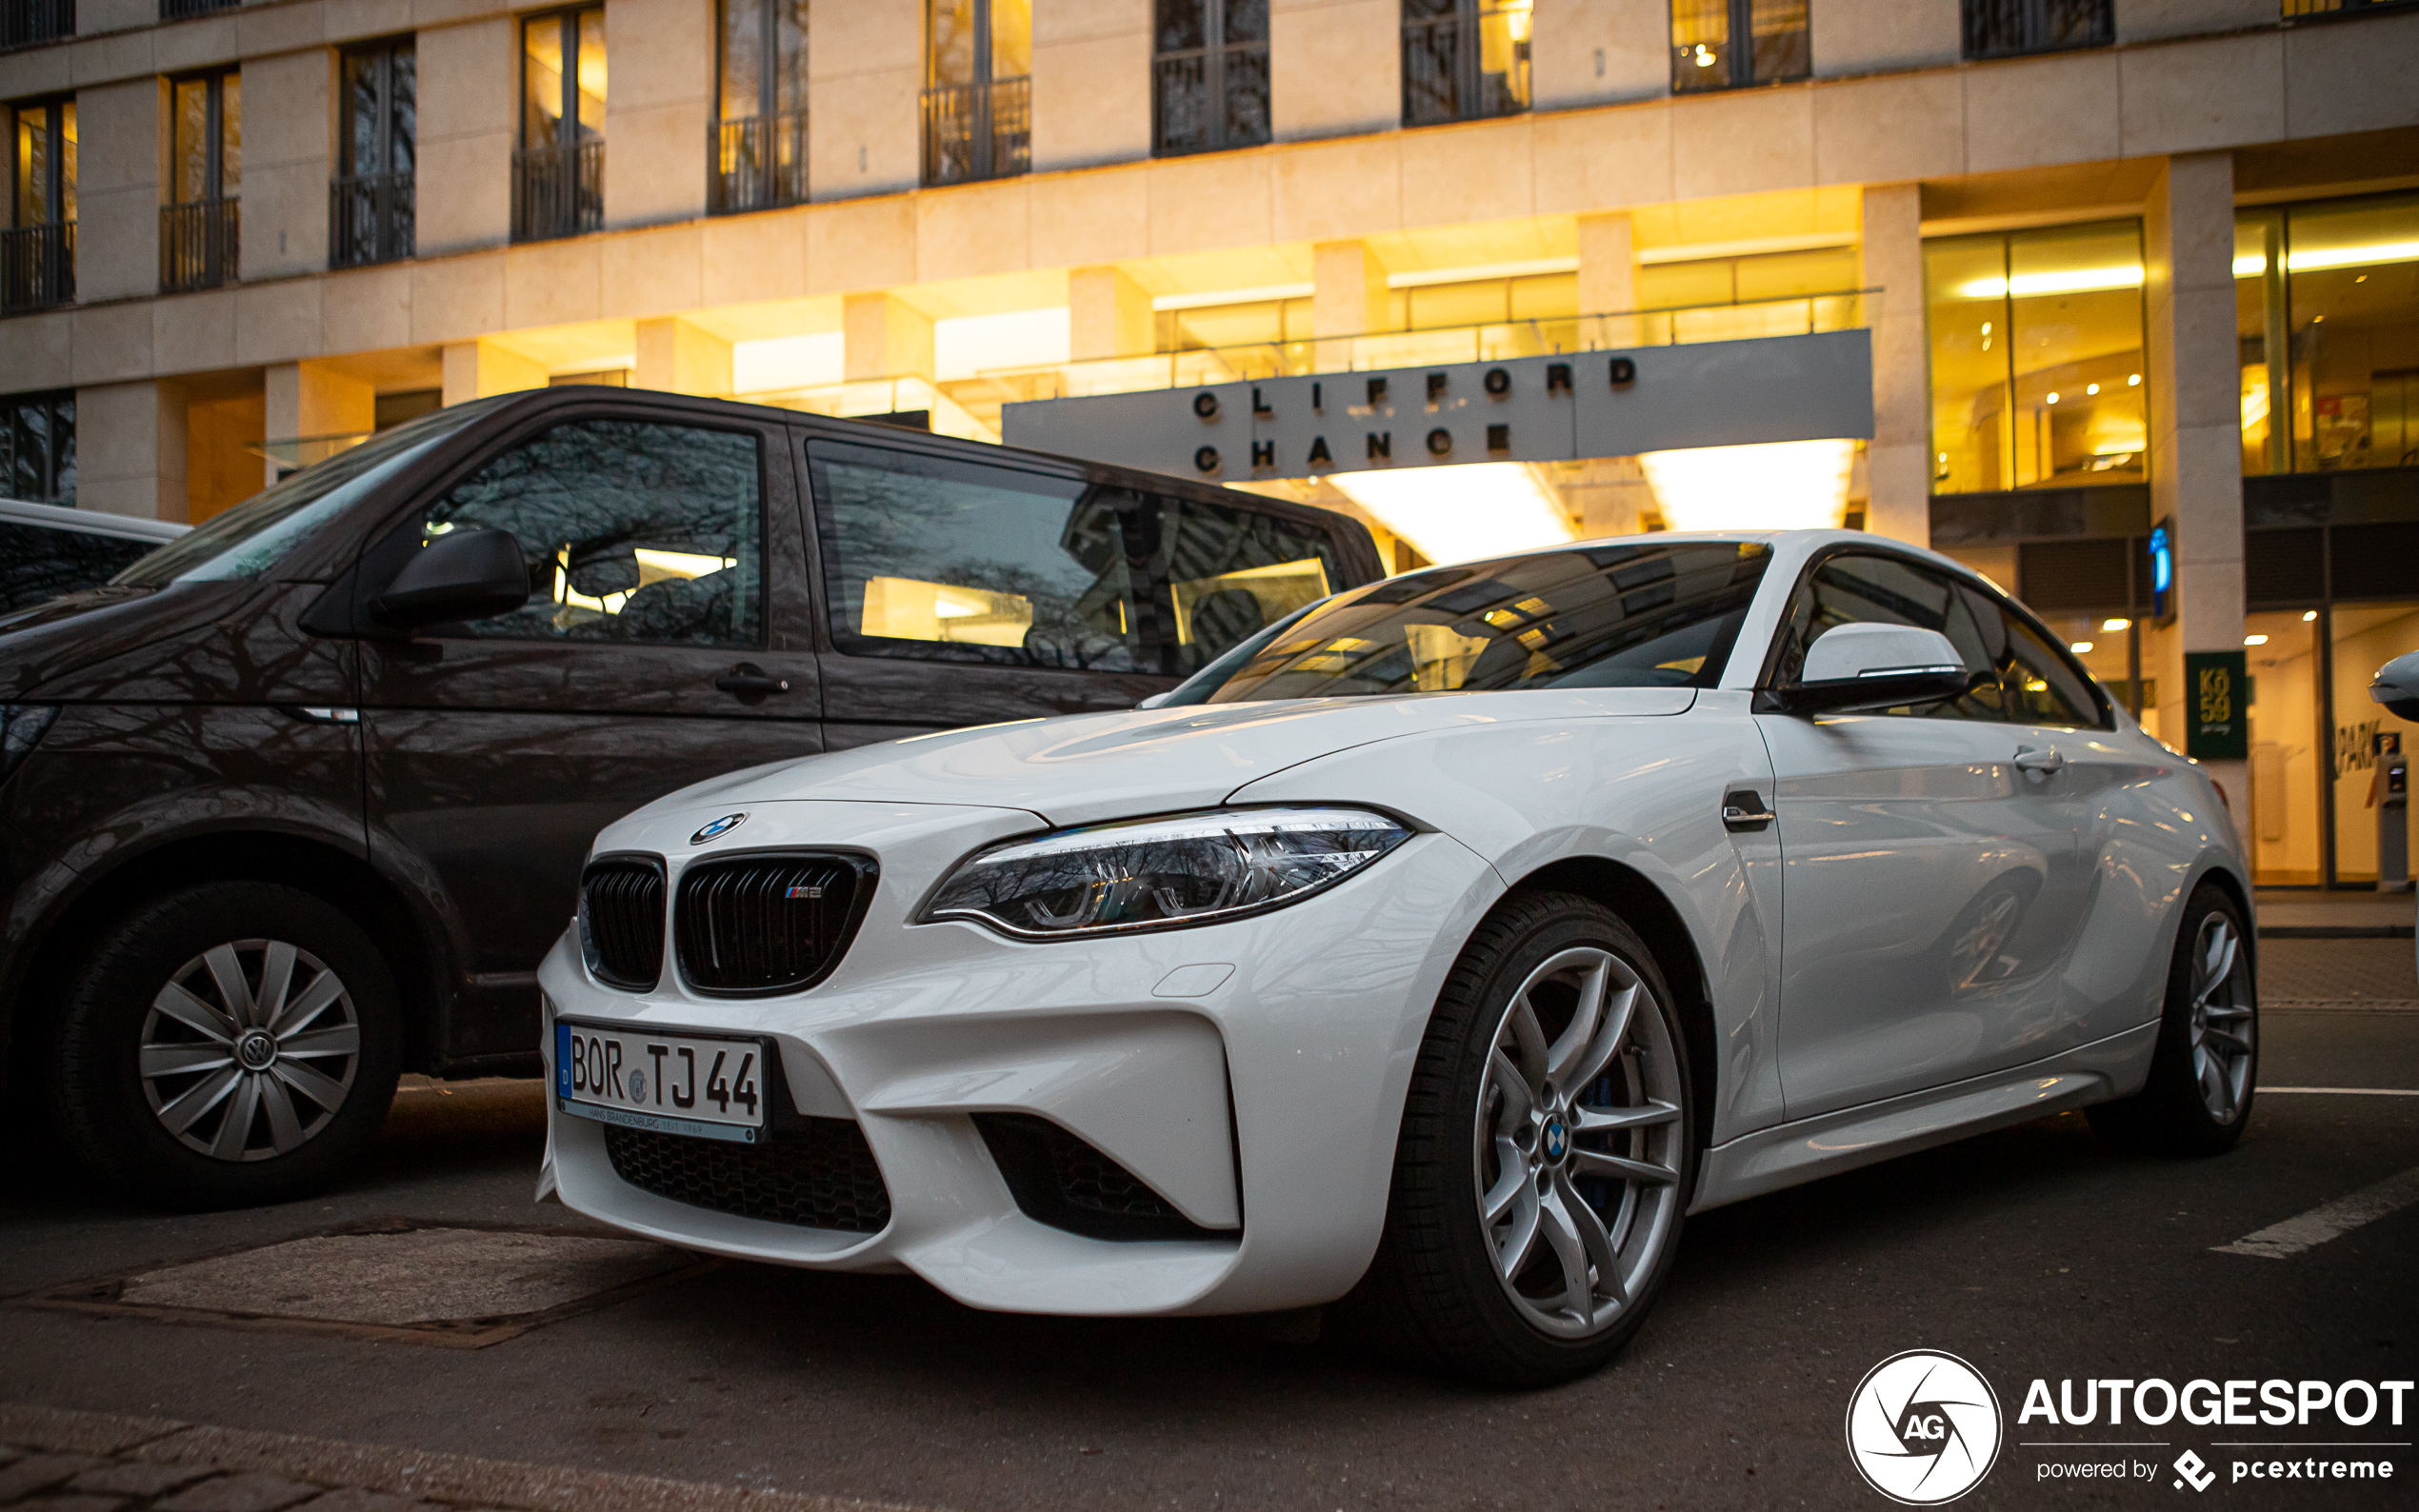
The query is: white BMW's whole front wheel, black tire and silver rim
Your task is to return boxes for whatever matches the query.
[1345,893,1696,1386]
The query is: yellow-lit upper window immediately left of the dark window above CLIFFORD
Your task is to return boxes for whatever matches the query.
[924,0,1033,184]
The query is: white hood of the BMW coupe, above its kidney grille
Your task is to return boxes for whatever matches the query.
[641,687,1696,825]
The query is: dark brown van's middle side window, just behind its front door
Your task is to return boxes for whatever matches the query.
[808,440,1159,672]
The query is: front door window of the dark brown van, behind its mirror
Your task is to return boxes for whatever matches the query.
[421,421,765,646]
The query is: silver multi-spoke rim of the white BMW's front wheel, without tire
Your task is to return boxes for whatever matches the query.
[1470,945,1686,1338]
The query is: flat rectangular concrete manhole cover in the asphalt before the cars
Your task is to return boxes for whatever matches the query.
[24,1220,713,1345]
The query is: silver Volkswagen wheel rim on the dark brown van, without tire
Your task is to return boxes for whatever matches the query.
[138,939,360,1162]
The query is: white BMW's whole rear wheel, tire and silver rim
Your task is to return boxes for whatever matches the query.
[2088,885,2259,1157]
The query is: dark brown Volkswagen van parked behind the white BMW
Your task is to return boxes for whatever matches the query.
[0,388,1379,1207]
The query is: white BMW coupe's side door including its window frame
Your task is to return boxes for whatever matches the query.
[1756,551,2075,1118]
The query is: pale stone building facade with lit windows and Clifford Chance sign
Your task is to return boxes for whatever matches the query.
[0,0,2419,885]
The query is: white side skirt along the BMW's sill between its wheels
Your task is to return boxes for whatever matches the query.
[1689,1019,2158,1212]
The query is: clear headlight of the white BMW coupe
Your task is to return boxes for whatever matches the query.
[922,808,1410,939]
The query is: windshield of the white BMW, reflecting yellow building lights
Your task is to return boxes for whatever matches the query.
[1190,542,1773,704]
